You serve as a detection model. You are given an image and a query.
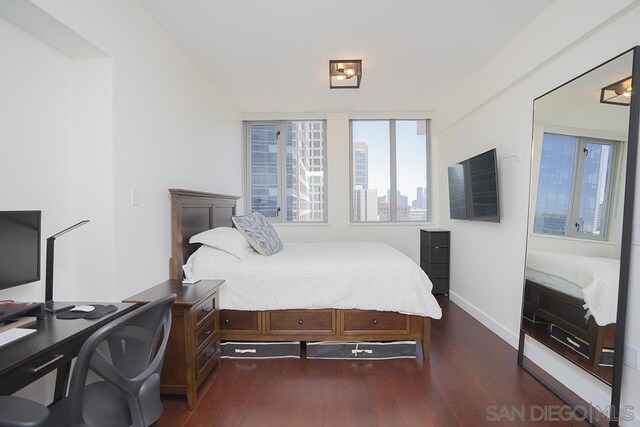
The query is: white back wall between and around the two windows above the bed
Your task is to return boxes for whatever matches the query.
[243,112,436,262]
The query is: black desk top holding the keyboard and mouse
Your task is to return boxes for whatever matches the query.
[0,301,135,389]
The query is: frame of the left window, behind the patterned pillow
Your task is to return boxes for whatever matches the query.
[243,119,329,225]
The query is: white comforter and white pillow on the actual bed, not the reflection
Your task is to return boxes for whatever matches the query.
[184,242,442,319]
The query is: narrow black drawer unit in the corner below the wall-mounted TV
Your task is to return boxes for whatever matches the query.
[420,229,451,295]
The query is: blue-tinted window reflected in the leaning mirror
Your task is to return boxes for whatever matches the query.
[533,133,617,240]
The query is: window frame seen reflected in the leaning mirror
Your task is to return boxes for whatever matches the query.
[531,131,623,242]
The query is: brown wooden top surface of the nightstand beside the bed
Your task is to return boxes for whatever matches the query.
[123,280,224,307]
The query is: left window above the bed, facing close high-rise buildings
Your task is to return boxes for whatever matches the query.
[246,120,326,222]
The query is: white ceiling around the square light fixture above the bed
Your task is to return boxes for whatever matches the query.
[139,0,553,113]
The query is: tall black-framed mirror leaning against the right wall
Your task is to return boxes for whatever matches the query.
[519,48,638,424]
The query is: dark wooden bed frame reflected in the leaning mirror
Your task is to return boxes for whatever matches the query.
[523,280,616,366]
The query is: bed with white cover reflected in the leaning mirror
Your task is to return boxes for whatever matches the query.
[523,250,620,366]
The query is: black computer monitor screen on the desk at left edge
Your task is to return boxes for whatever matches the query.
[0,211,40,289]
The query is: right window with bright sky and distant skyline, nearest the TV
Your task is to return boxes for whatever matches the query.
[351,120,430,222]
